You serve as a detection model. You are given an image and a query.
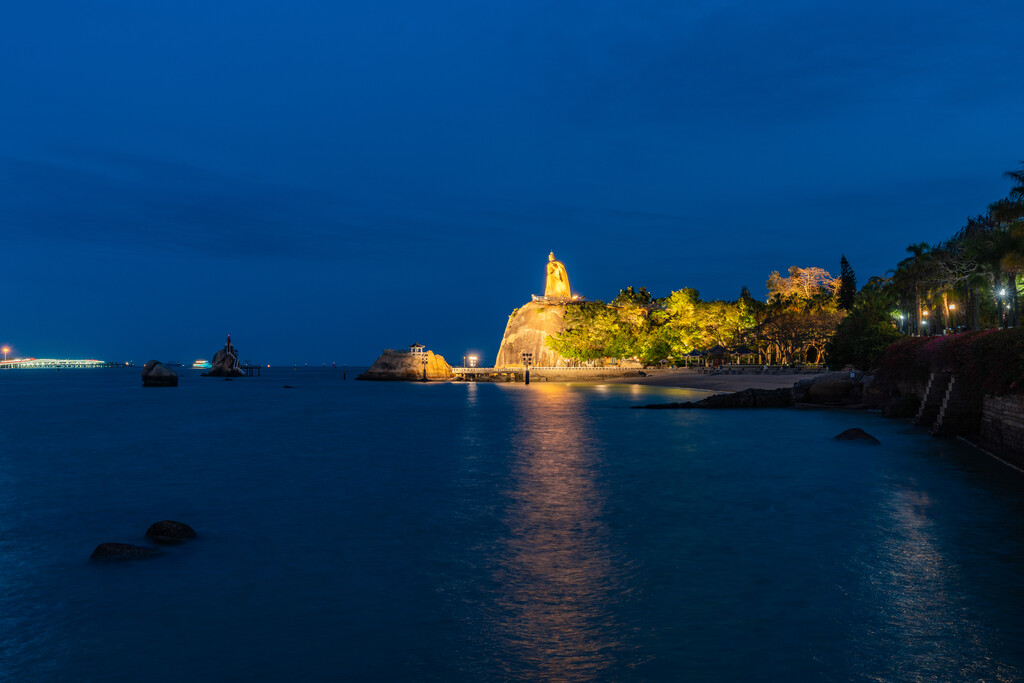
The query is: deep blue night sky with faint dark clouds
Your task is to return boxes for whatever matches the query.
[0,0,1024,365]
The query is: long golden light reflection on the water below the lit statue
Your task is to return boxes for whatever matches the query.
[495,384,618,680]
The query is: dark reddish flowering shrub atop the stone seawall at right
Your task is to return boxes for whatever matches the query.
[879,330,1024,394]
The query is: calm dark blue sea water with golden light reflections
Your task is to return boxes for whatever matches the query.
[0,369,1024,681]
